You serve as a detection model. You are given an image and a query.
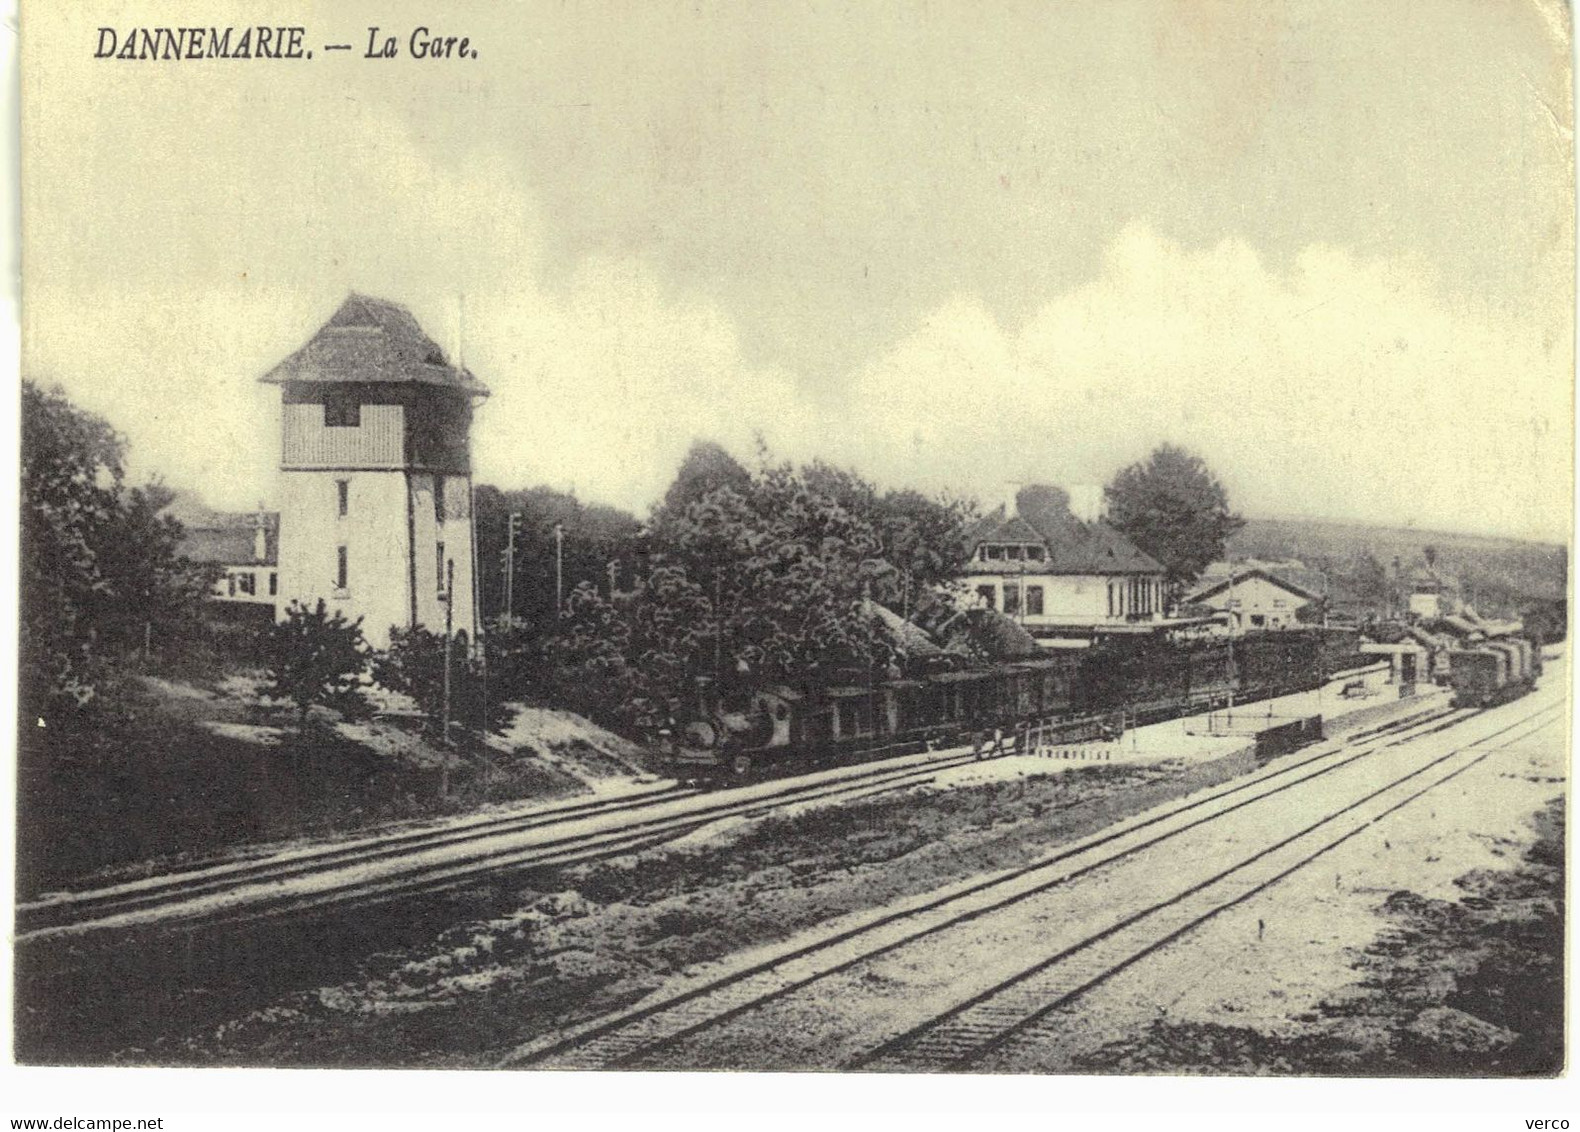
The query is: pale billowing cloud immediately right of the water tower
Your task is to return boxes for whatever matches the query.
[468,259,811,514]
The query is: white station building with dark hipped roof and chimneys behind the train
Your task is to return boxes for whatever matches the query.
[961,487,1164,643]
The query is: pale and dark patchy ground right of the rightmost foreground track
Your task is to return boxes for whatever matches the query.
[981,711,1567,1075]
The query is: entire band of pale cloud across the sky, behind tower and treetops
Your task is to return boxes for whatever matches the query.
[25,112,1572,538]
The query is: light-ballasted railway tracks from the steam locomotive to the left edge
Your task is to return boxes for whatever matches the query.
[16,751,973,944]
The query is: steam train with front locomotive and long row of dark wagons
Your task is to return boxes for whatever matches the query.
[662,631,1349,784]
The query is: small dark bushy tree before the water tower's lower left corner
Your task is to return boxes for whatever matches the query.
[267,598,368,732]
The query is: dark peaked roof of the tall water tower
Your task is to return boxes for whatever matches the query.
[259,292,488,397]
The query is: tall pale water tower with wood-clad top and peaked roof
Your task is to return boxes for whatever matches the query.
[261,294,488,648]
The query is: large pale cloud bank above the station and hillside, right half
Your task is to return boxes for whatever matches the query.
[839,225,1572,538]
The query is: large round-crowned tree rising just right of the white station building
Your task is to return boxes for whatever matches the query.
[1103,444,1245,594]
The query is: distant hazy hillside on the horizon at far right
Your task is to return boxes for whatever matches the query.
[1229,519,1569,613]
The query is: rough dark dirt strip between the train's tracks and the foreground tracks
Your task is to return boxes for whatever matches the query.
[163,746,1270,1067]
